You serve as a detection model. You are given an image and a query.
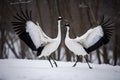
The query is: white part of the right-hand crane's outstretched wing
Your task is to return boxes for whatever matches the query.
[74,25,104,48]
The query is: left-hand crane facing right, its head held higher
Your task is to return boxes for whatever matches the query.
[12,9,62,67]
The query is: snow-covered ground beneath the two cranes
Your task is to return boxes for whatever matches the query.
[0,59,120,80]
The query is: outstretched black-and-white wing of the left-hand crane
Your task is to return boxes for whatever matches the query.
[12,9,46,52]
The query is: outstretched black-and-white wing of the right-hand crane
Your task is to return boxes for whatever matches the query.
[77,16,113,53]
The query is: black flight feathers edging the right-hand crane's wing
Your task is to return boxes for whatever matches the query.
[85,16,114,53]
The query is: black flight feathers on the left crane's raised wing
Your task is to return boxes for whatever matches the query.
[12,10,37,50]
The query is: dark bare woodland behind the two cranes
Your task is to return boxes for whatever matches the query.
[0,0,120,65]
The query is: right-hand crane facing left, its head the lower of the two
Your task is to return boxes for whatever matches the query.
[65,17,113,69]
